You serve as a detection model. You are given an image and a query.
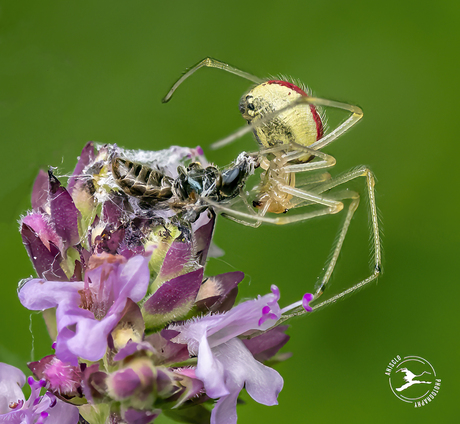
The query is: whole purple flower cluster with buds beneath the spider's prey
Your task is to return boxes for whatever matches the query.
[0,143,311,424]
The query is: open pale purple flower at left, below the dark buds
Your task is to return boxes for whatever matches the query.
[19,254,150,365]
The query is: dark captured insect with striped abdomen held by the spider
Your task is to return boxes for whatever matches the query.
[111,153,258,222]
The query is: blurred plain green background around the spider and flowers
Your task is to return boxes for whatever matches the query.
[0,0,460,423]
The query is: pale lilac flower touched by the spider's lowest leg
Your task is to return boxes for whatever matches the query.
[170,286,283,424]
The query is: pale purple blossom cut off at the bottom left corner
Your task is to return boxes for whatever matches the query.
[0,363,79,424]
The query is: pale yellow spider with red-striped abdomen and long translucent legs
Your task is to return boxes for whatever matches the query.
[163,58,381,306]
